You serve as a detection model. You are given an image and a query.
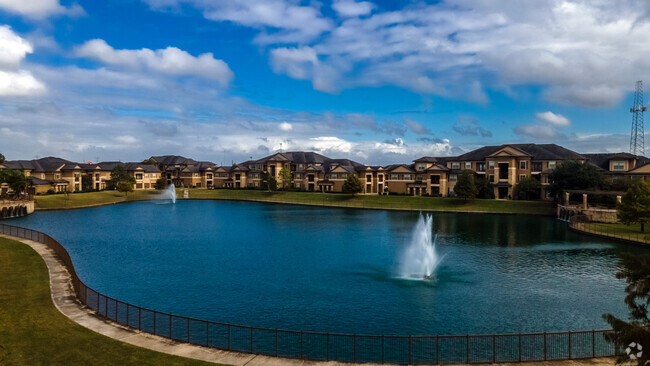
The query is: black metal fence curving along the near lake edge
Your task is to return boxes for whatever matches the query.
[0,224,616,364]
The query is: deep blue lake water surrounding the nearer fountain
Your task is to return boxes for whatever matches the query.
[8,201,636,334]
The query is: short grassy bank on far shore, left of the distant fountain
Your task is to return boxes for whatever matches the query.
[35,191,159,210]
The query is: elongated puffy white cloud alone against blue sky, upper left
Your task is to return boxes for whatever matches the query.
[75,39,233,85]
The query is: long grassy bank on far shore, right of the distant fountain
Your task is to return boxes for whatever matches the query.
[177,189,555,215]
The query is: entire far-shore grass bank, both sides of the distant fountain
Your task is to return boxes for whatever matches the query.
[36,188,555,216]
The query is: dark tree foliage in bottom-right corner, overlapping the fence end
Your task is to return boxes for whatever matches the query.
[603,254,650,366]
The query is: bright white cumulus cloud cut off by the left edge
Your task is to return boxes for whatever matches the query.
[0,26,45,96]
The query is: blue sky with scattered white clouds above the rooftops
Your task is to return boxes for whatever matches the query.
[0,0,650,165]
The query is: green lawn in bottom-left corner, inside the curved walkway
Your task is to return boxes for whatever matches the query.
[0,238,218,366]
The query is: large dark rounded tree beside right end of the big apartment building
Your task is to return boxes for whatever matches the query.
[548,160,607,197]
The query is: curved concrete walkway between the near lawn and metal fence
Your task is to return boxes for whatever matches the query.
[0,235,614,366]
